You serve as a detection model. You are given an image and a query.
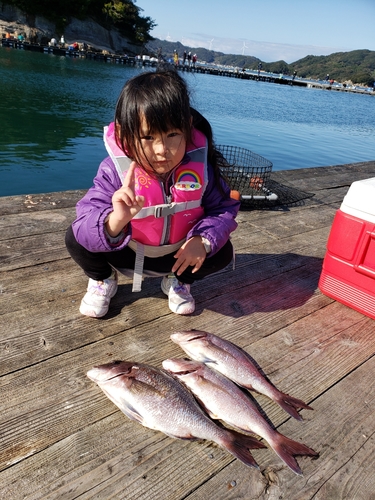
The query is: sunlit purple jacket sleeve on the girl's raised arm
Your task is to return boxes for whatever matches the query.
[72,157,131,252]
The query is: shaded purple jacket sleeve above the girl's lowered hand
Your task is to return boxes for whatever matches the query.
[187,165,240,257]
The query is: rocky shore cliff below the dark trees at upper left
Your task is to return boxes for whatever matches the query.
[0,2,142,54]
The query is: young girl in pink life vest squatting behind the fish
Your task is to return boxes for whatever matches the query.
[66,70,239,318]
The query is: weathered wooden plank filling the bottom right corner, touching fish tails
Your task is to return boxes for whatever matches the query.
[185,357,375,500]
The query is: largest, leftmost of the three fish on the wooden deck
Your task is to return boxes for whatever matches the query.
[87,360,266,469]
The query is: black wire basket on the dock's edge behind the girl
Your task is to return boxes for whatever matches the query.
[216,145,277,205]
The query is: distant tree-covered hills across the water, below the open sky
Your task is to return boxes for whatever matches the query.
[147,38,375,86]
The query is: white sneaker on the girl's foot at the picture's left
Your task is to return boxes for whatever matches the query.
[79,271,117,318]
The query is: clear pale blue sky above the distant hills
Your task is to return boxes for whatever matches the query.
[134,0,375,64]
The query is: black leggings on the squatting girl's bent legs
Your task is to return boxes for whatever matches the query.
[65,226,233,285]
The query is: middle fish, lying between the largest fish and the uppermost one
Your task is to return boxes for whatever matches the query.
[163,358,319,475]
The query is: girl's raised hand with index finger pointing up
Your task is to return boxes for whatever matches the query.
[106,161,145,236]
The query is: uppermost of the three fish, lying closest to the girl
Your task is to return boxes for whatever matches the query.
[170,330,313,420]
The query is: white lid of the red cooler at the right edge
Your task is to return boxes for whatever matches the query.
[340,177,375,222]
